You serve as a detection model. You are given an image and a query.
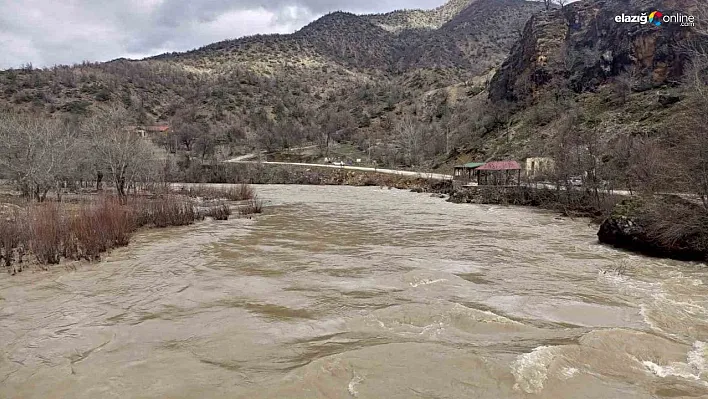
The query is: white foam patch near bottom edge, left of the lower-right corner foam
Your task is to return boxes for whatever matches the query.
[511,346,558,393]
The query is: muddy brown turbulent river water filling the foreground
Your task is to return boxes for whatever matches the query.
[0,186,708,399]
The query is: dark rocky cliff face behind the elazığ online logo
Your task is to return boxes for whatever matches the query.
[489,0,696,101]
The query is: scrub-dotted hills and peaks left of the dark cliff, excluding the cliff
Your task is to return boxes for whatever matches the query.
[0,0,542,163]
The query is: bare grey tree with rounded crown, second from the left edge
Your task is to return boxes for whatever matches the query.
[83,108,153,203]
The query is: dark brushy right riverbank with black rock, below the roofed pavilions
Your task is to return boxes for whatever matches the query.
[435,186,708,262]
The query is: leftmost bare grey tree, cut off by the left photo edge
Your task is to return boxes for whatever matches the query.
[0,114,76,201]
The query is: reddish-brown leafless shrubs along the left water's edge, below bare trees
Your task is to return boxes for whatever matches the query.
[0,185,263,274]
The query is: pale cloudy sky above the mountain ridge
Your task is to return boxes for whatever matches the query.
[0,0,445,69]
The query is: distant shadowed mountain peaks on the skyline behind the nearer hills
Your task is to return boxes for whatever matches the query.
[155,0,541,73]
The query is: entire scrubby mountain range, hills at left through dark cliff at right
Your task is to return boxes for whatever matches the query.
[0,0,704,175]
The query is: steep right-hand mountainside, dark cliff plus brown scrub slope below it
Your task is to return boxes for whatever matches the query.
[450,0,708,172]
